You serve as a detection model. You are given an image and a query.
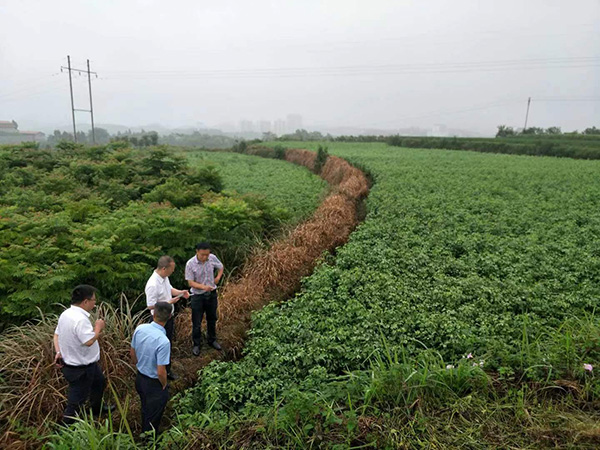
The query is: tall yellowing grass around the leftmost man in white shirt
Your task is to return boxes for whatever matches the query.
[0,296,146,445]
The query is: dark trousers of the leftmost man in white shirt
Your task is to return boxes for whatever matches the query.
[62,362,106,425]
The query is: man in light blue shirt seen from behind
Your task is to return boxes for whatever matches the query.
[129,302,172,433]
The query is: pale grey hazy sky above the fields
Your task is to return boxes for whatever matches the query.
[0,0,600,134]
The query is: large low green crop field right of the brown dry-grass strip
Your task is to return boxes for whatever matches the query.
[179,143,600,444]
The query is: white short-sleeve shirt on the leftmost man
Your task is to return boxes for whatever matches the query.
[54,305,100,366]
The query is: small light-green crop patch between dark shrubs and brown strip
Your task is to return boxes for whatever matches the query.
[188,151,327,222]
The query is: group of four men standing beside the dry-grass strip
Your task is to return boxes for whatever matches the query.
[54,242,224,432]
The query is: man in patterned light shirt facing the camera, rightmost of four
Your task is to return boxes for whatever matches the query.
[185,242,223,356]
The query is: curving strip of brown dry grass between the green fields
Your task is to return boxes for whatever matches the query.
[177,149,369,356]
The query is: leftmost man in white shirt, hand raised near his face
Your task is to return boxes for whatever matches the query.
[54,284,108,425]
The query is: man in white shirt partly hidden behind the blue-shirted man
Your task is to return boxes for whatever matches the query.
[145,255,190,380]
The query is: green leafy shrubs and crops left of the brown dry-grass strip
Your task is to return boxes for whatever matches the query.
[0,145,324,328]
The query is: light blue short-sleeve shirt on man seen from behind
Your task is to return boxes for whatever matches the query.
[131,322,171,378]
